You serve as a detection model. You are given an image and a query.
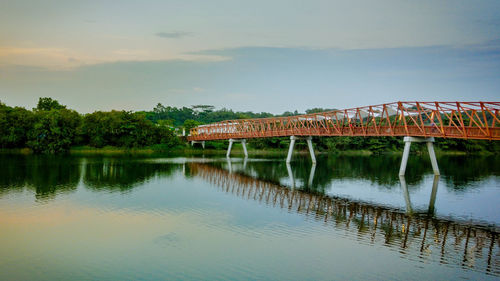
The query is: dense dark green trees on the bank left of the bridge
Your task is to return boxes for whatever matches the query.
[0,98,180,153]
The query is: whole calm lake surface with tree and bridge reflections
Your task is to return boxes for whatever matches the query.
[0,155,500,280]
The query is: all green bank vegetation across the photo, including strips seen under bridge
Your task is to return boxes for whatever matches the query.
[0,97,500,154]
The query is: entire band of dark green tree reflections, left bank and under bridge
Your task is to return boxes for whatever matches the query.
[0,154,500,200]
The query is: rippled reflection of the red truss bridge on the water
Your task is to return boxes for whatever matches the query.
[186,163,500,275]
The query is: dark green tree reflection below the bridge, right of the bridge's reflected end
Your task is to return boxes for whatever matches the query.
[219,155,500,193]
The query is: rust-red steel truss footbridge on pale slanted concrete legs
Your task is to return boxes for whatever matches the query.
[188,101,500,175]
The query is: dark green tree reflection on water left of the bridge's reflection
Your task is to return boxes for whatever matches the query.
[0,155,181,200]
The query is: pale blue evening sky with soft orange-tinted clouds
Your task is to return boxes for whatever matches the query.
[0,0,500,113]
